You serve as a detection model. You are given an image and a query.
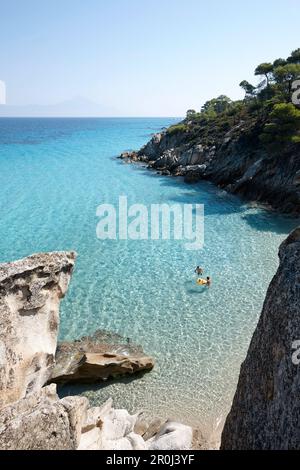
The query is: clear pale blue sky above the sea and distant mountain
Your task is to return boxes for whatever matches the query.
[0,0,300,116]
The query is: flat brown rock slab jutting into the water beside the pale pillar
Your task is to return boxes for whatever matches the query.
[51,331,154,383]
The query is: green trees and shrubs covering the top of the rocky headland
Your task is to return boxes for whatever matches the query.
[167,48,300,152]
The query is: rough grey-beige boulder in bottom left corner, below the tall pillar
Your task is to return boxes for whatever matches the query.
[0,385,87,450]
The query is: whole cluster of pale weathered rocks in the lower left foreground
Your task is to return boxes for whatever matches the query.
[0,252,193,450]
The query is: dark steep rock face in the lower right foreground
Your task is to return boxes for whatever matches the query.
[221,228,300,450]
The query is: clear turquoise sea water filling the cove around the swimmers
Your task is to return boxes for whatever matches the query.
[0,119,297,440]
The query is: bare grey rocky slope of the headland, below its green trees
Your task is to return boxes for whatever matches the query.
[121,121,300,215]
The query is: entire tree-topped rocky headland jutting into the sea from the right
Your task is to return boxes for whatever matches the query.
[121,49,300,216]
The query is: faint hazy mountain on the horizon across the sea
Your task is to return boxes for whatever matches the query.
[0,97,117,117]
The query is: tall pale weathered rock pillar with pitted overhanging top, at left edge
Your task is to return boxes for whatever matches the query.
[0,253,75,409]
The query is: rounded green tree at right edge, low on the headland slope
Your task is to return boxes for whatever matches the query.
[260,103,300,149]
